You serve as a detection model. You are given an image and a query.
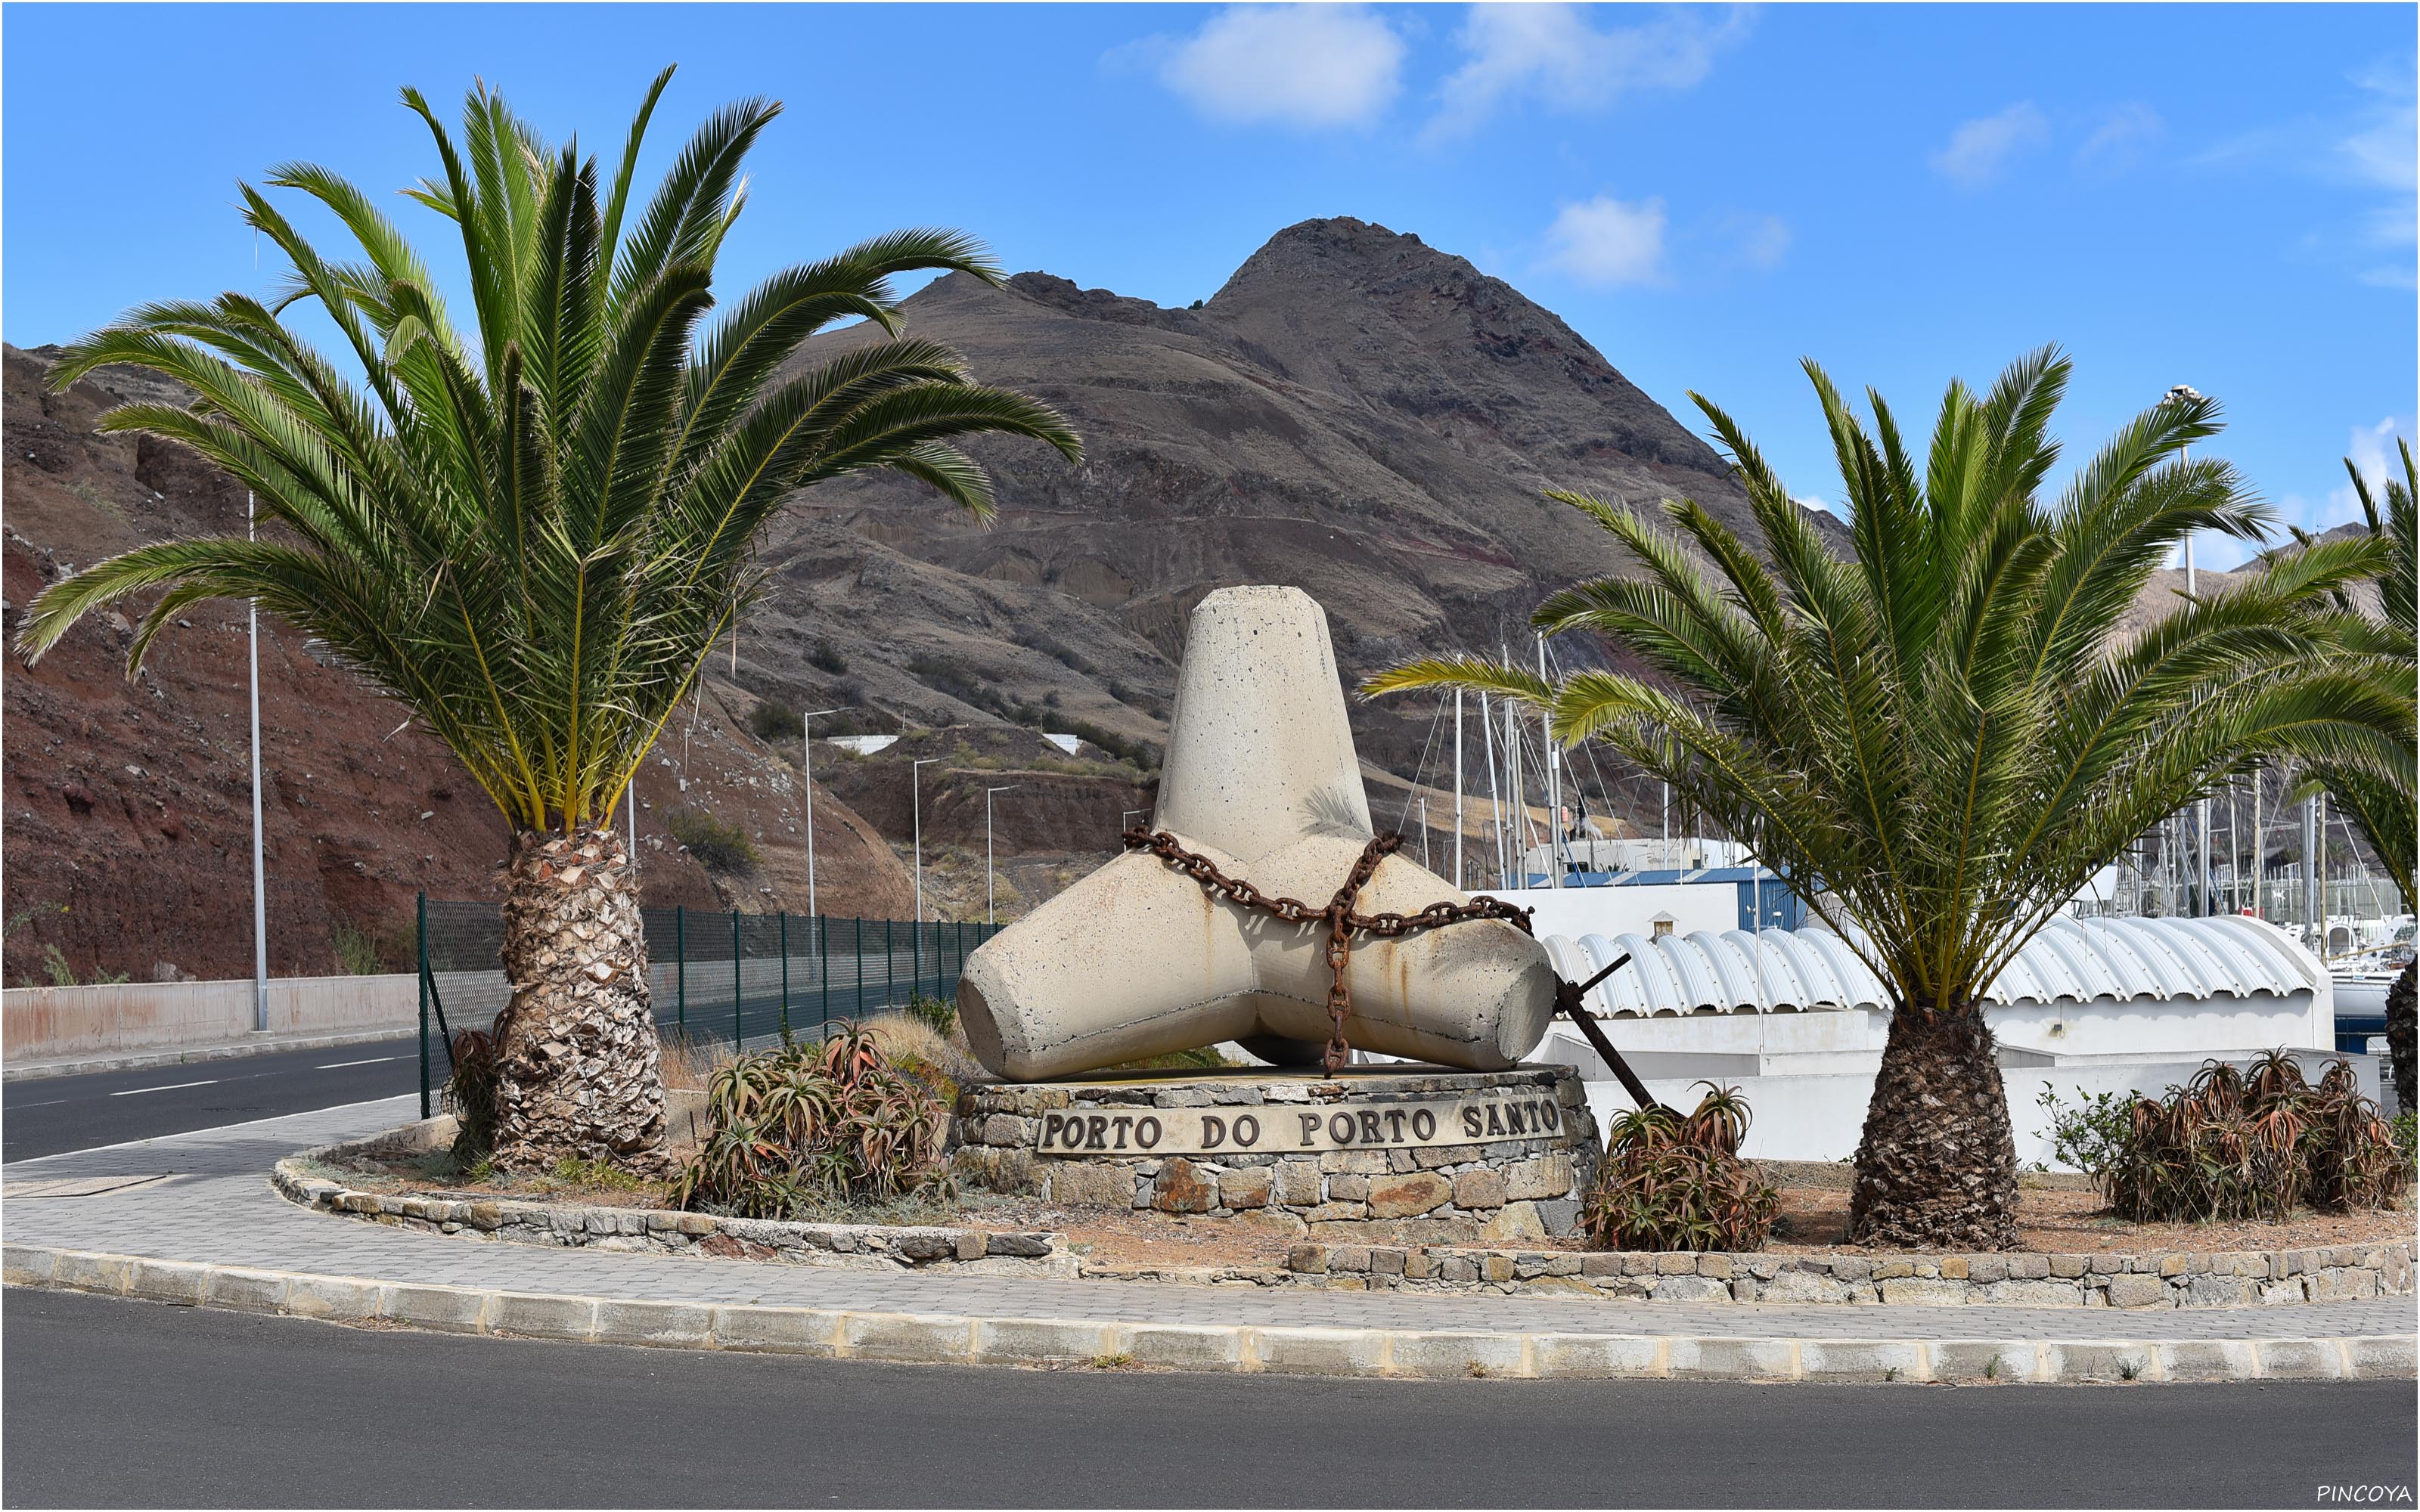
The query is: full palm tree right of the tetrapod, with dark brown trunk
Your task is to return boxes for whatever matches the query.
[1370,349,2388,1248]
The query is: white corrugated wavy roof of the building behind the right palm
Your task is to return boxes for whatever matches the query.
[1544,917,2321,1018]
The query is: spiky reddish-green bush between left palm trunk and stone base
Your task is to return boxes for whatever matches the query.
[673,1026,948,1217]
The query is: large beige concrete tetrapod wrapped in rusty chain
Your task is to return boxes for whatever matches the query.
[958,588,1556,1081]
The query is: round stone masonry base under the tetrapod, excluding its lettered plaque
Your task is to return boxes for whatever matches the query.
[951,1067,1602,1244]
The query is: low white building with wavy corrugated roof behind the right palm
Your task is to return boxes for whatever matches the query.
[1522,909,2379,1166]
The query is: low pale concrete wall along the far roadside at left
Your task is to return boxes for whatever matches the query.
[0,972,421,1060]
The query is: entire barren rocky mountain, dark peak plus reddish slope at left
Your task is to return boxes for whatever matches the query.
[0,218,2275,982]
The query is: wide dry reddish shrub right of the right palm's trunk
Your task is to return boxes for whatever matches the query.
[2101,1050,2410,1222]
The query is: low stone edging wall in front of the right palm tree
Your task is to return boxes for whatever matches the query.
[1270,1241,2412,1306]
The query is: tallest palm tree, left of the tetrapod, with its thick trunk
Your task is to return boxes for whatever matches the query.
[20,68,1081,1166]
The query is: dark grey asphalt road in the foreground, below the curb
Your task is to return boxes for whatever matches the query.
[0,1292,2415,1507]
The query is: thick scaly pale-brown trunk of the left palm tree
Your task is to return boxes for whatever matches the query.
[494,830,666,1173]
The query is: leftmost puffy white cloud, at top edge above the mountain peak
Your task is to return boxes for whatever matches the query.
[1146,5,1404,129]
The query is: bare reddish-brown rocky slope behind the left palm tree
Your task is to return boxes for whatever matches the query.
[0,349,910,987]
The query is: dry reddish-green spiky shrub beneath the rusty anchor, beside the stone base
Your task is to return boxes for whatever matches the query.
[1581,1081,1781,1250]
